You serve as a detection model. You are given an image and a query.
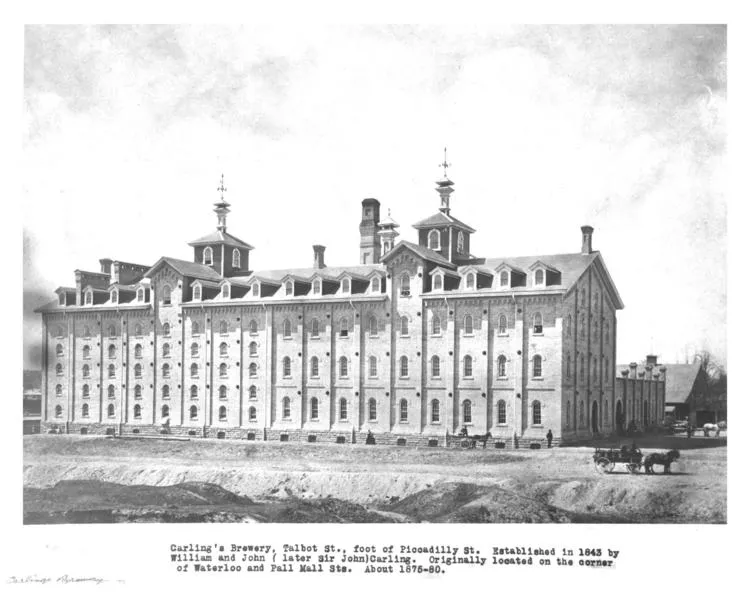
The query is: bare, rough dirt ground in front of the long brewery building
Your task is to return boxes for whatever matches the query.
[24,436,727,523]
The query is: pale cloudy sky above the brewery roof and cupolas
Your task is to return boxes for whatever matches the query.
[21,25,728,368]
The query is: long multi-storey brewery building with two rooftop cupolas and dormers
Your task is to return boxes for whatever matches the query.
[38,170,627,447]
